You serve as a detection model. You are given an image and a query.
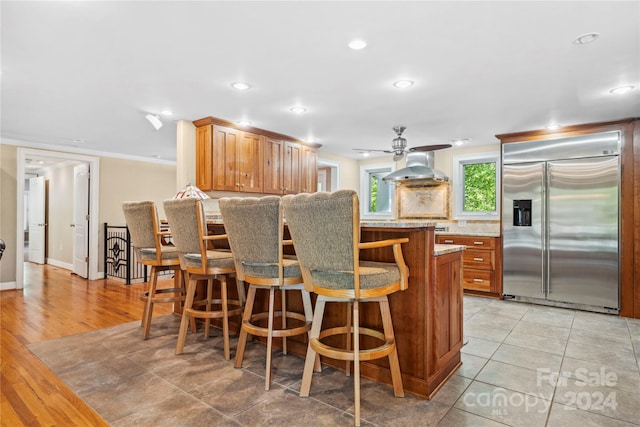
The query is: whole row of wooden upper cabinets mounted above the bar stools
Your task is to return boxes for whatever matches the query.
[193,117,320,195]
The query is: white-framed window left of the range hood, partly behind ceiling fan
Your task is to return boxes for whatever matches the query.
[360,164,395,219]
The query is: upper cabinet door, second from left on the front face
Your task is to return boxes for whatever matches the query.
[237,132,263,193]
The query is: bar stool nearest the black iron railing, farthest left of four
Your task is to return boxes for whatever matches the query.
[122,201,186,339]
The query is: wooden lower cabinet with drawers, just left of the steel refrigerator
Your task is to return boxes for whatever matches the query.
[436,235,502,298]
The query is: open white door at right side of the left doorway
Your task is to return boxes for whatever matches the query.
[71,164,89,279]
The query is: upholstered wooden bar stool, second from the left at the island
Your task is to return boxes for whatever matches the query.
[164,198,244,360]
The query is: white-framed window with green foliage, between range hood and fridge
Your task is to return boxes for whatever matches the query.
[453,153,500,220]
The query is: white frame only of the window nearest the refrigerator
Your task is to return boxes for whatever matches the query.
[453,151,502,220]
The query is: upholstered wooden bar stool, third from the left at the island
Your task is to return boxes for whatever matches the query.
[219,196,320,390]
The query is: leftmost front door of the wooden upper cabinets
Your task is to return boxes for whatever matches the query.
[212,126,240,191]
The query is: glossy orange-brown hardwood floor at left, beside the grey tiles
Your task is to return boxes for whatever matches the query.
[0,263,173,427]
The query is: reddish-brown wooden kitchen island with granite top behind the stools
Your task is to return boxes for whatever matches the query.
[208,217,464,398]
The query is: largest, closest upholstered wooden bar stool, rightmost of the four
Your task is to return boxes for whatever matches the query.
[282,190,409,426]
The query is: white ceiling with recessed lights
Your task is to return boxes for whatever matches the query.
[0,1,640,165]
